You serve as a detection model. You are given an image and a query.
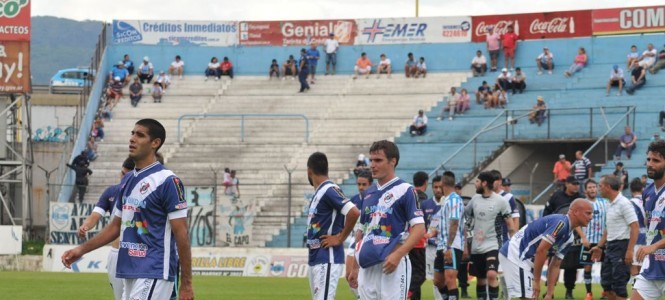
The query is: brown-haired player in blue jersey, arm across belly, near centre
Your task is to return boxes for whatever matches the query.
[349,140,425,300]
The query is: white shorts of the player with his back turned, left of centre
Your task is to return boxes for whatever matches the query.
[309,264,344,300]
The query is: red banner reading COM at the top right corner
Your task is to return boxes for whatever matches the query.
[592,5,665,35]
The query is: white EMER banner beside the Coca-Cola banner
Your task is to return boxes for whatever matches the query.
[356,17,471,45]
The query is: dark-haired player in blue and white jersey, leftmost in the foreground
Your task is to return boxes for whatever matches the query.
[62,119,194,299]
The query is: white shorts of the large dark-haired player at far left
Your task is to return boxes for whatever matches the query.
[122,278,175,300]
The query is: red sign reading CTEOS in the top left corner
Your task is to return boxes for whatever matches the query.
[0,0,32,41]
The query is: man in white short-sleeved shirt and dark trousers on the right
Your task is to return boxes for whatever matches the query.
[591,176,639,299]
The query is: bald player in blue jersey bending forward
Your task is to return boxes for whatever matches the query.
[499,199,593,299]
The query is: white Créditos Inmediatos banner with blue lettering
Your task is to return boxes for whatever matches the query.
[113,20,238,47]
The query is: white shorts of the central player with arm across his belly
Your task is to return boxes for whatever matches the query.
[358,255,411,300]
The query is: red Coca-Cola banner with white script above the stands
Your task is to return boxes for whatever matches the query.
[472,10,591,42]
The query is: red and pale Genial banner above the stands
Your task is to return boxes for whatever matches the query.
[240,20,357,46]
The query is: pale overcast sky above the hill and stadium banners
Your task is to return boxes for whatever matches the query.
[32,0,663,22]
